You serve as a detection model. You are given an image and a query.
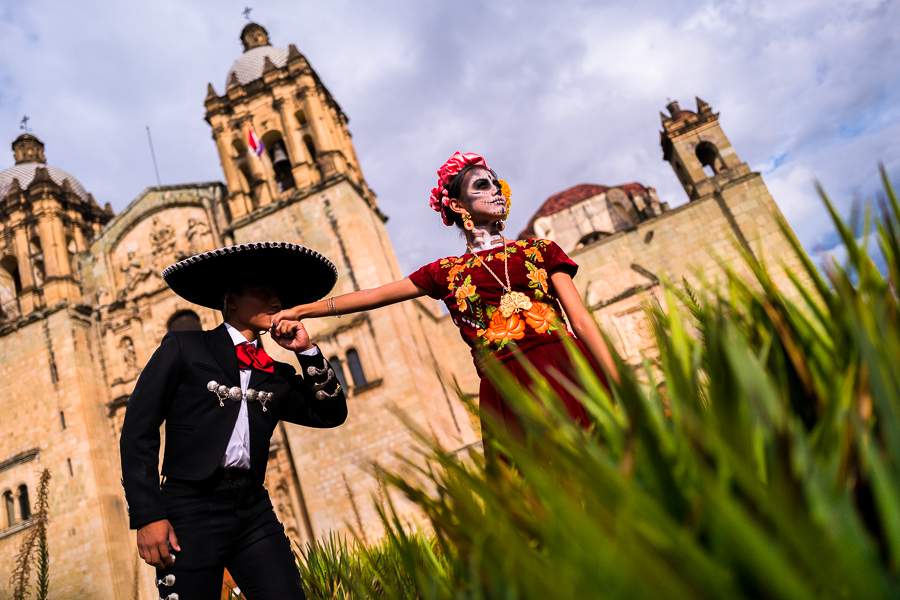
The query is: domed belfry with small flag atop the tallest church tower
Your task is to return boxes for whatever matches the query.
[205,22,375,222]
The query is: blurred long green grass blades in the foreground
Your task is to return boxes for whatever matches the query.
[301,171,900,600]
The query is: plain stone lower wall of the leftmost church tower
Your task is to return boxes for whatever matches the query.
[0,306,131,598]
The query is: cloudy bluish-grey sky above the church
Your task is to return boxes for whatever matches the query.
[0,0,900,272]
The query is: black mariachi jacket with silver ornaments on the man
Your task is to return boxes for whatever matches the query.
[119,324,347,529]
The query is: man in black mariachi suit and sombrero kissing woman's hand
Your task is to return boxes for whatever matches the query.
[120,242,347,600]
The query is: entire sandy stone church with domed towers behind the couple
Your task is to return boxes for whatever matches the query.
[0,23,804,600]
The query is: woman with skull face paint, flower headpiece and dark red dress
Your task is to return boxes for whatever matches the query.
[274,152,616,430]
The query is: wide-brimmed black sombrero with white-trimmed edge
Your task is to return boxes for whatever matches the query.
[162,242,337,310]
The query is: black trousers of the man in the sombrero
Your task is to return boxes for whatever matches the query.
[156,476,306,600]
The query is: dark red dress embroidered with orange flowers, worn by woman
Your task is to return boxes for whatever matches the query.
[409,240,602,428]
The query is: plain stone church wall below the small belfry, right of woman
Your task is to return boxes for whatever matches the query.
[571,173,799,364]
